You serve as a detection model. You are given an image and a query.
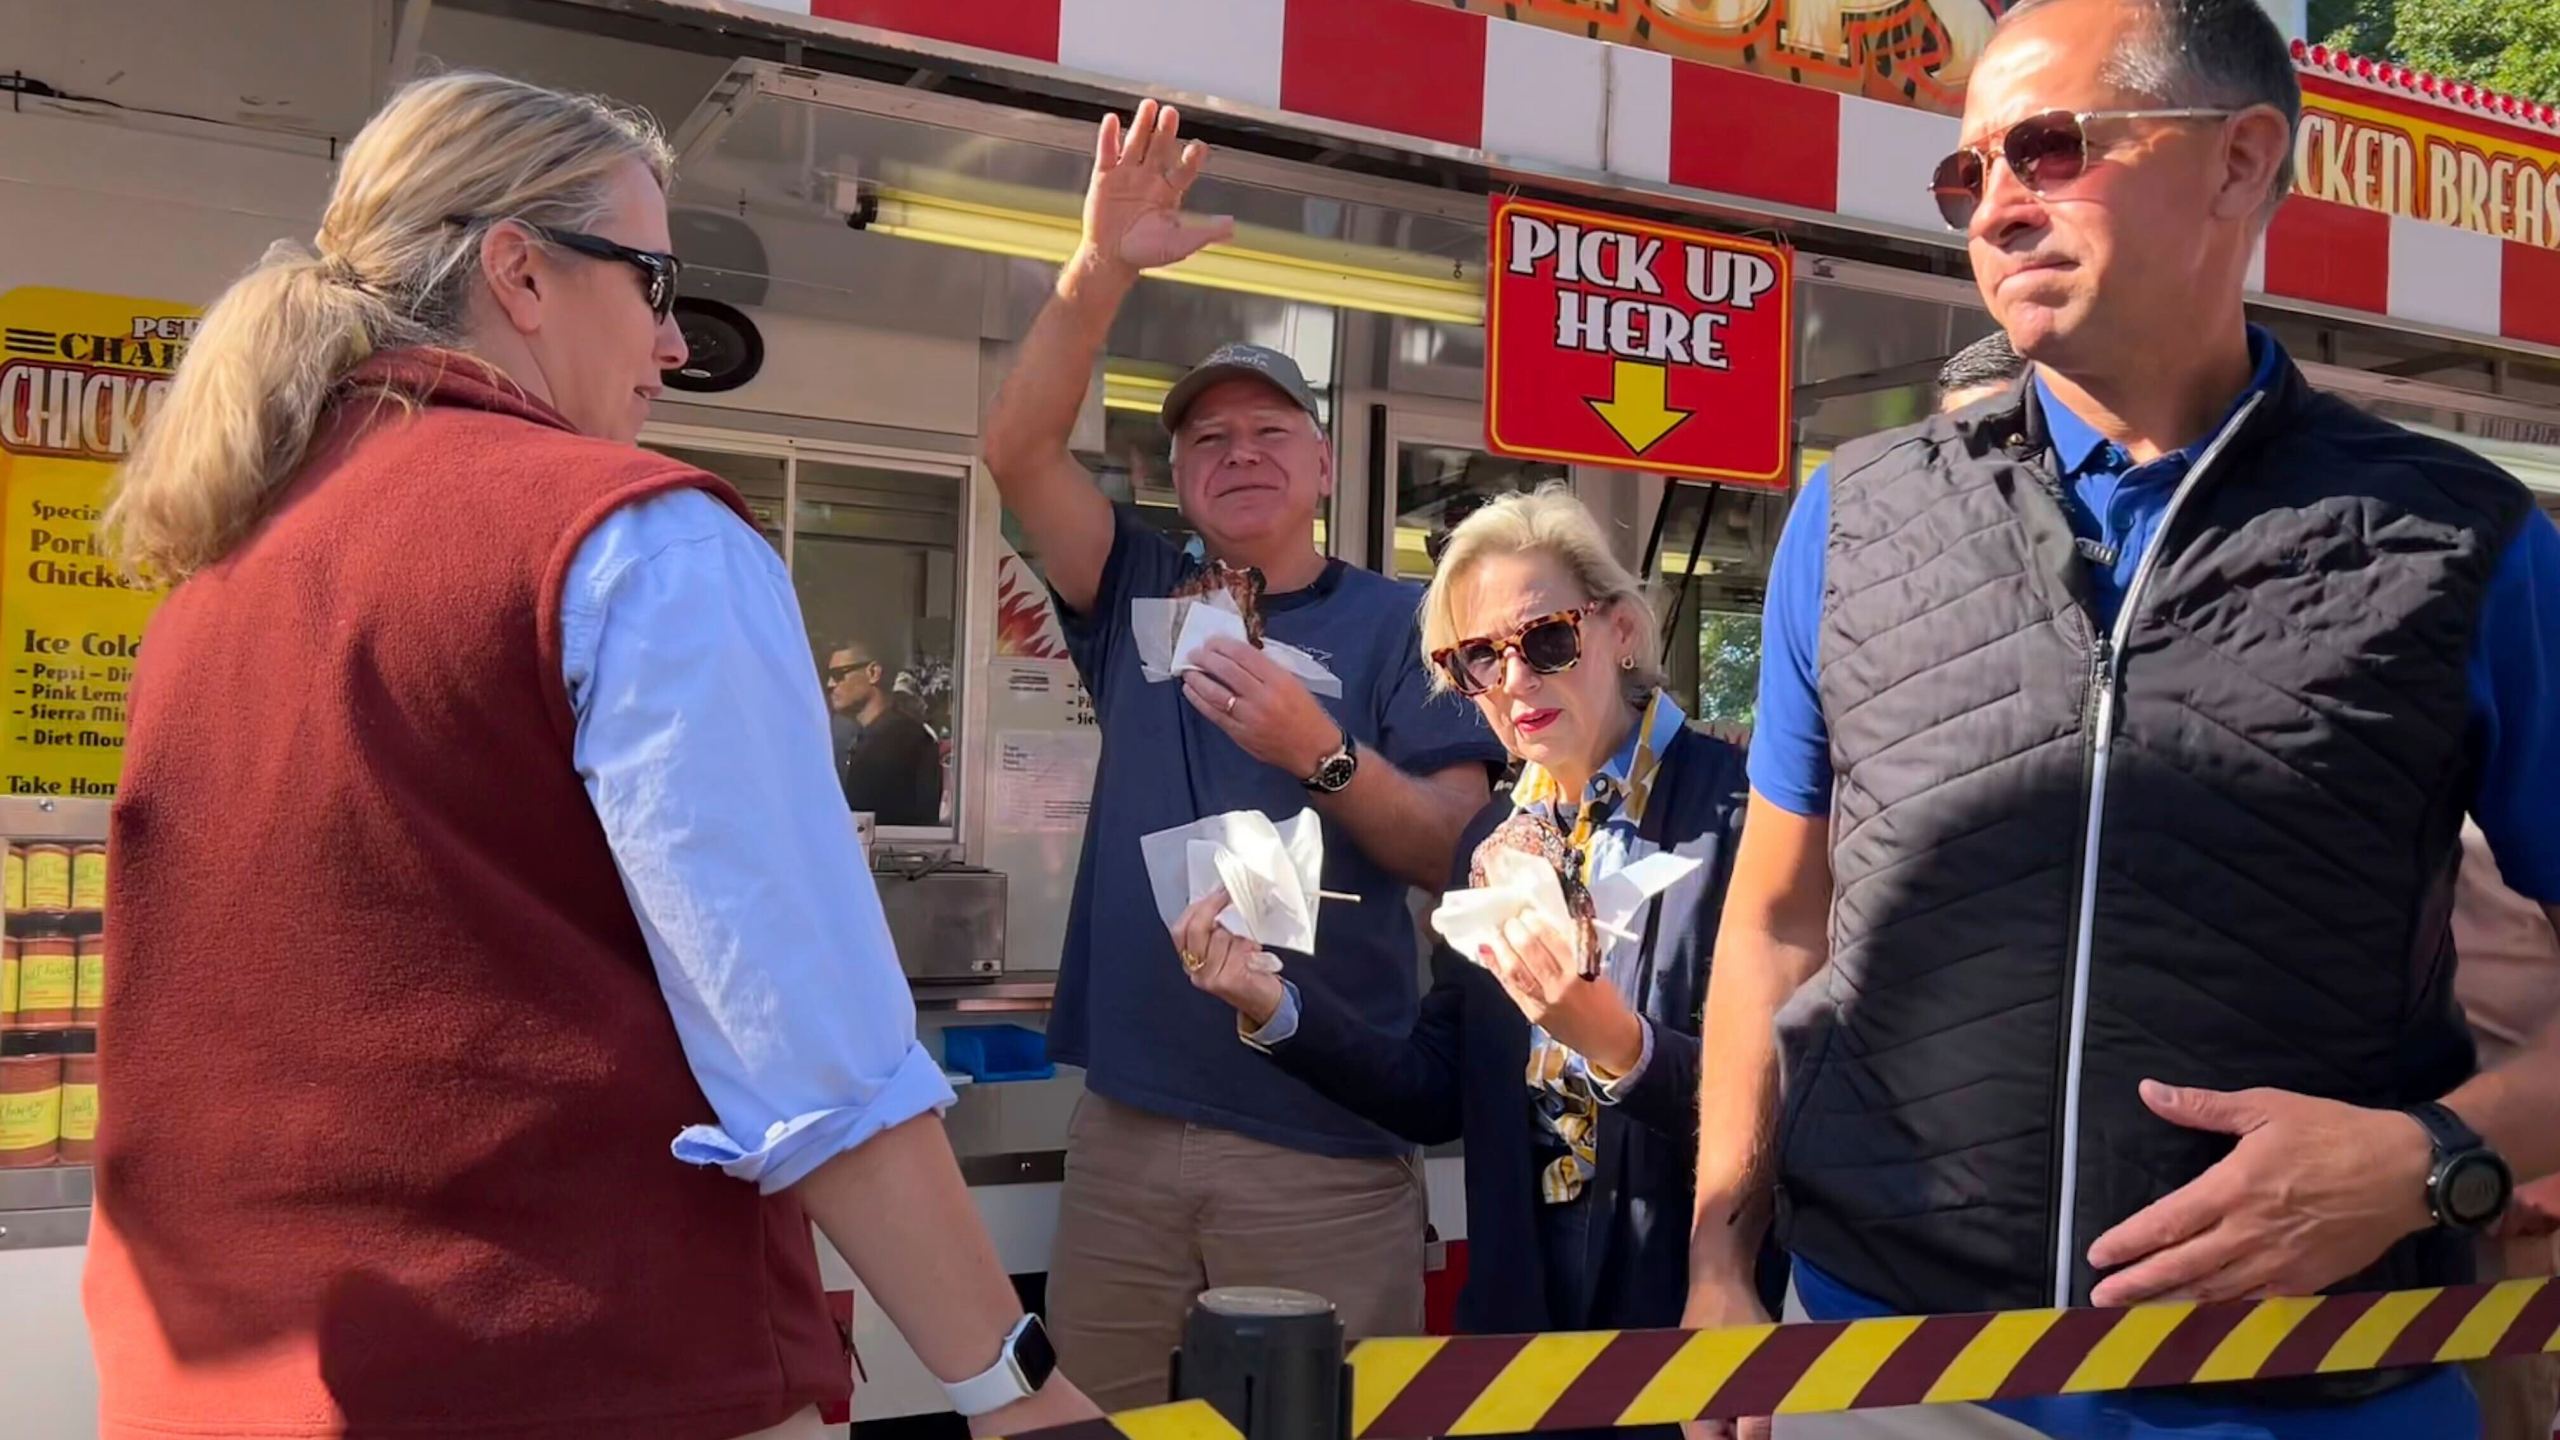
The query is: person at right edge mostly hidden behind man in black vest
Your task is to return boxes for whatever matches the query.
[2452,825,2560,1440]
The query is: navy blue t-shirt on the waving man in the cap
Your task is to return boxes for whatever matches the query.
[1050,505,1503,1156]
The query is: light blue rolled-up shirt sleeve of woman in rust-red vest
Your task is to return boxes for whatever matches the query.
[561,489,952,1194]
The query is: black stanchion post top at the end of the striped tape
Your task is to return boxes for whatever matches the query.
[1172,1286,1352,1440]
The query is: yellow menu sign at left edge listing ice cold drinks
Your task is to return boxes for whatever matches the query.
[0,287,197,797]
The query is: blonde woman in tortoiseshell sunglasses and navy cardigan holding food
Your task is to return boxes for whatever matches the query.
[1172,487,1784,1393]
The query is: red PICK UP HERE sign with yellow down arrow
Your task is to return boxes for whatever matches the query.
[1485,197,1795,487]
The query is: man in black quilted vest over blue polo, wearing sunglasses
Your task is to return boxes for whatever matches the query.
[1687,0,2560,1440]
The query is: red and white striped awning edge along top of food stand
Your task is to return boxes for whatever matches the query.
[678,0,2560,348]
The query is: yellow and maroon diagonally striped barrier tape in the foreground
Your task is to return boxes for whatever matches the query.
[988,1279,2560,1440]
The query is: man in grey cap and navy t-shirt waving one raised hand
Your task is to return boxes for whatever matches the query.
[986,100,1503,1407]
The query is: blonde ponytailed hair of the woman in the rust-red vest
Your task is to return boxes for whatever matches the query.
[102,72,673,584]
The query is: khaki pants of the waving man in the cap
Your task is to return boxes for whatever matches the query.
[1050,1094,1426,1412]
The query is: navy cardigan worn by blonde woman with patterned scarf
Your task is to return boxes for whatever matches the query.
[1272,730,1782,1335]
